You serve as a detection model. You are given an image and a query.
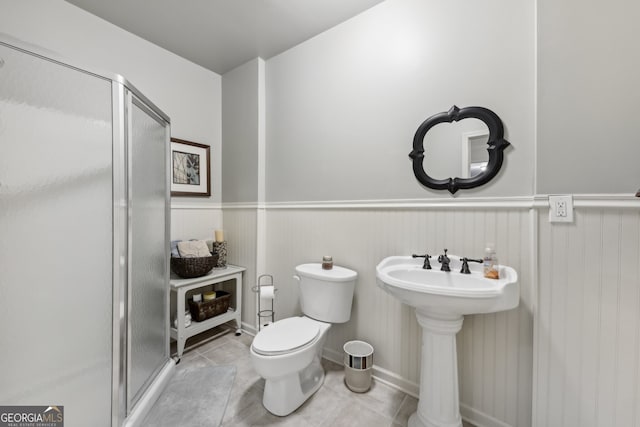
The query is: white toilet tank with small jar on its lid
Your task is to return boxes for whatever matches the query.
[295,263,358,323]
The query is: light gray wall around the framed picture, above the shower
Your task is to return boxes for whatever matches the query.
[0,0,221,205]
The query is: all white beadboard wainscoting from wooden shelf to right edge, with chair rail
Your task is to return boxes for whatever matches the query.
[225,195,640,427]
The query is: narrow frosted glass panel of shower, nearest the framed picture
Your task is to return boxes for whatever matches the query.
[127,95,169,408]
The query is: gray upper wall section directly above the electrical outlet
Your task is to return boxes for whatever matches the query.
[537,0,640,194]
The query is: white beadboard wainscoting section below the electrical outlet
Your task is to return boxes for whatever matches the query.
[533,207,640,427]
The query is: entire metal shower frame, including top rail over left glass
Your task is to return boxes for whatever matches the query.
[0,33,175,427]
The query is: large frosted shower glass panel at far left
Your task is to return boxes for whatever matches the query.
[0,43,113,427]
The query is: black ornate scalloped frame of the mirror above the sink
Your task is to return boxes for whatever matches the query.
[409,105,509,194]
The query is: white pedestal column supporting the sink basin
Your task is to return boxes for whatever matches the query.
[408,309,463,427]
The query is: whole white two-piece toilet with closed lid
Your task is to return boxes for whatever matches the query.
[251,263,358,416]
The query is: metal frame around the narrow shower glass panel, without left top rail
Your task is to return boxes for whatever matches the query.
[111,81,175,427]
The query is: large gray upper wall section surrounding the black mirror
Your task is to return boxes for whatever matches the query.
[264,0,535,202]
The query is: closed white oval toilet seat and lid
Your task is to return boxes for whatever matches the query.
[252,317,320,356]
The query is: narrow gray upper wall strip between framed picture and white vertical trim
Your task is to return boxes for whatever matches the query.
[222,58,259,203]
